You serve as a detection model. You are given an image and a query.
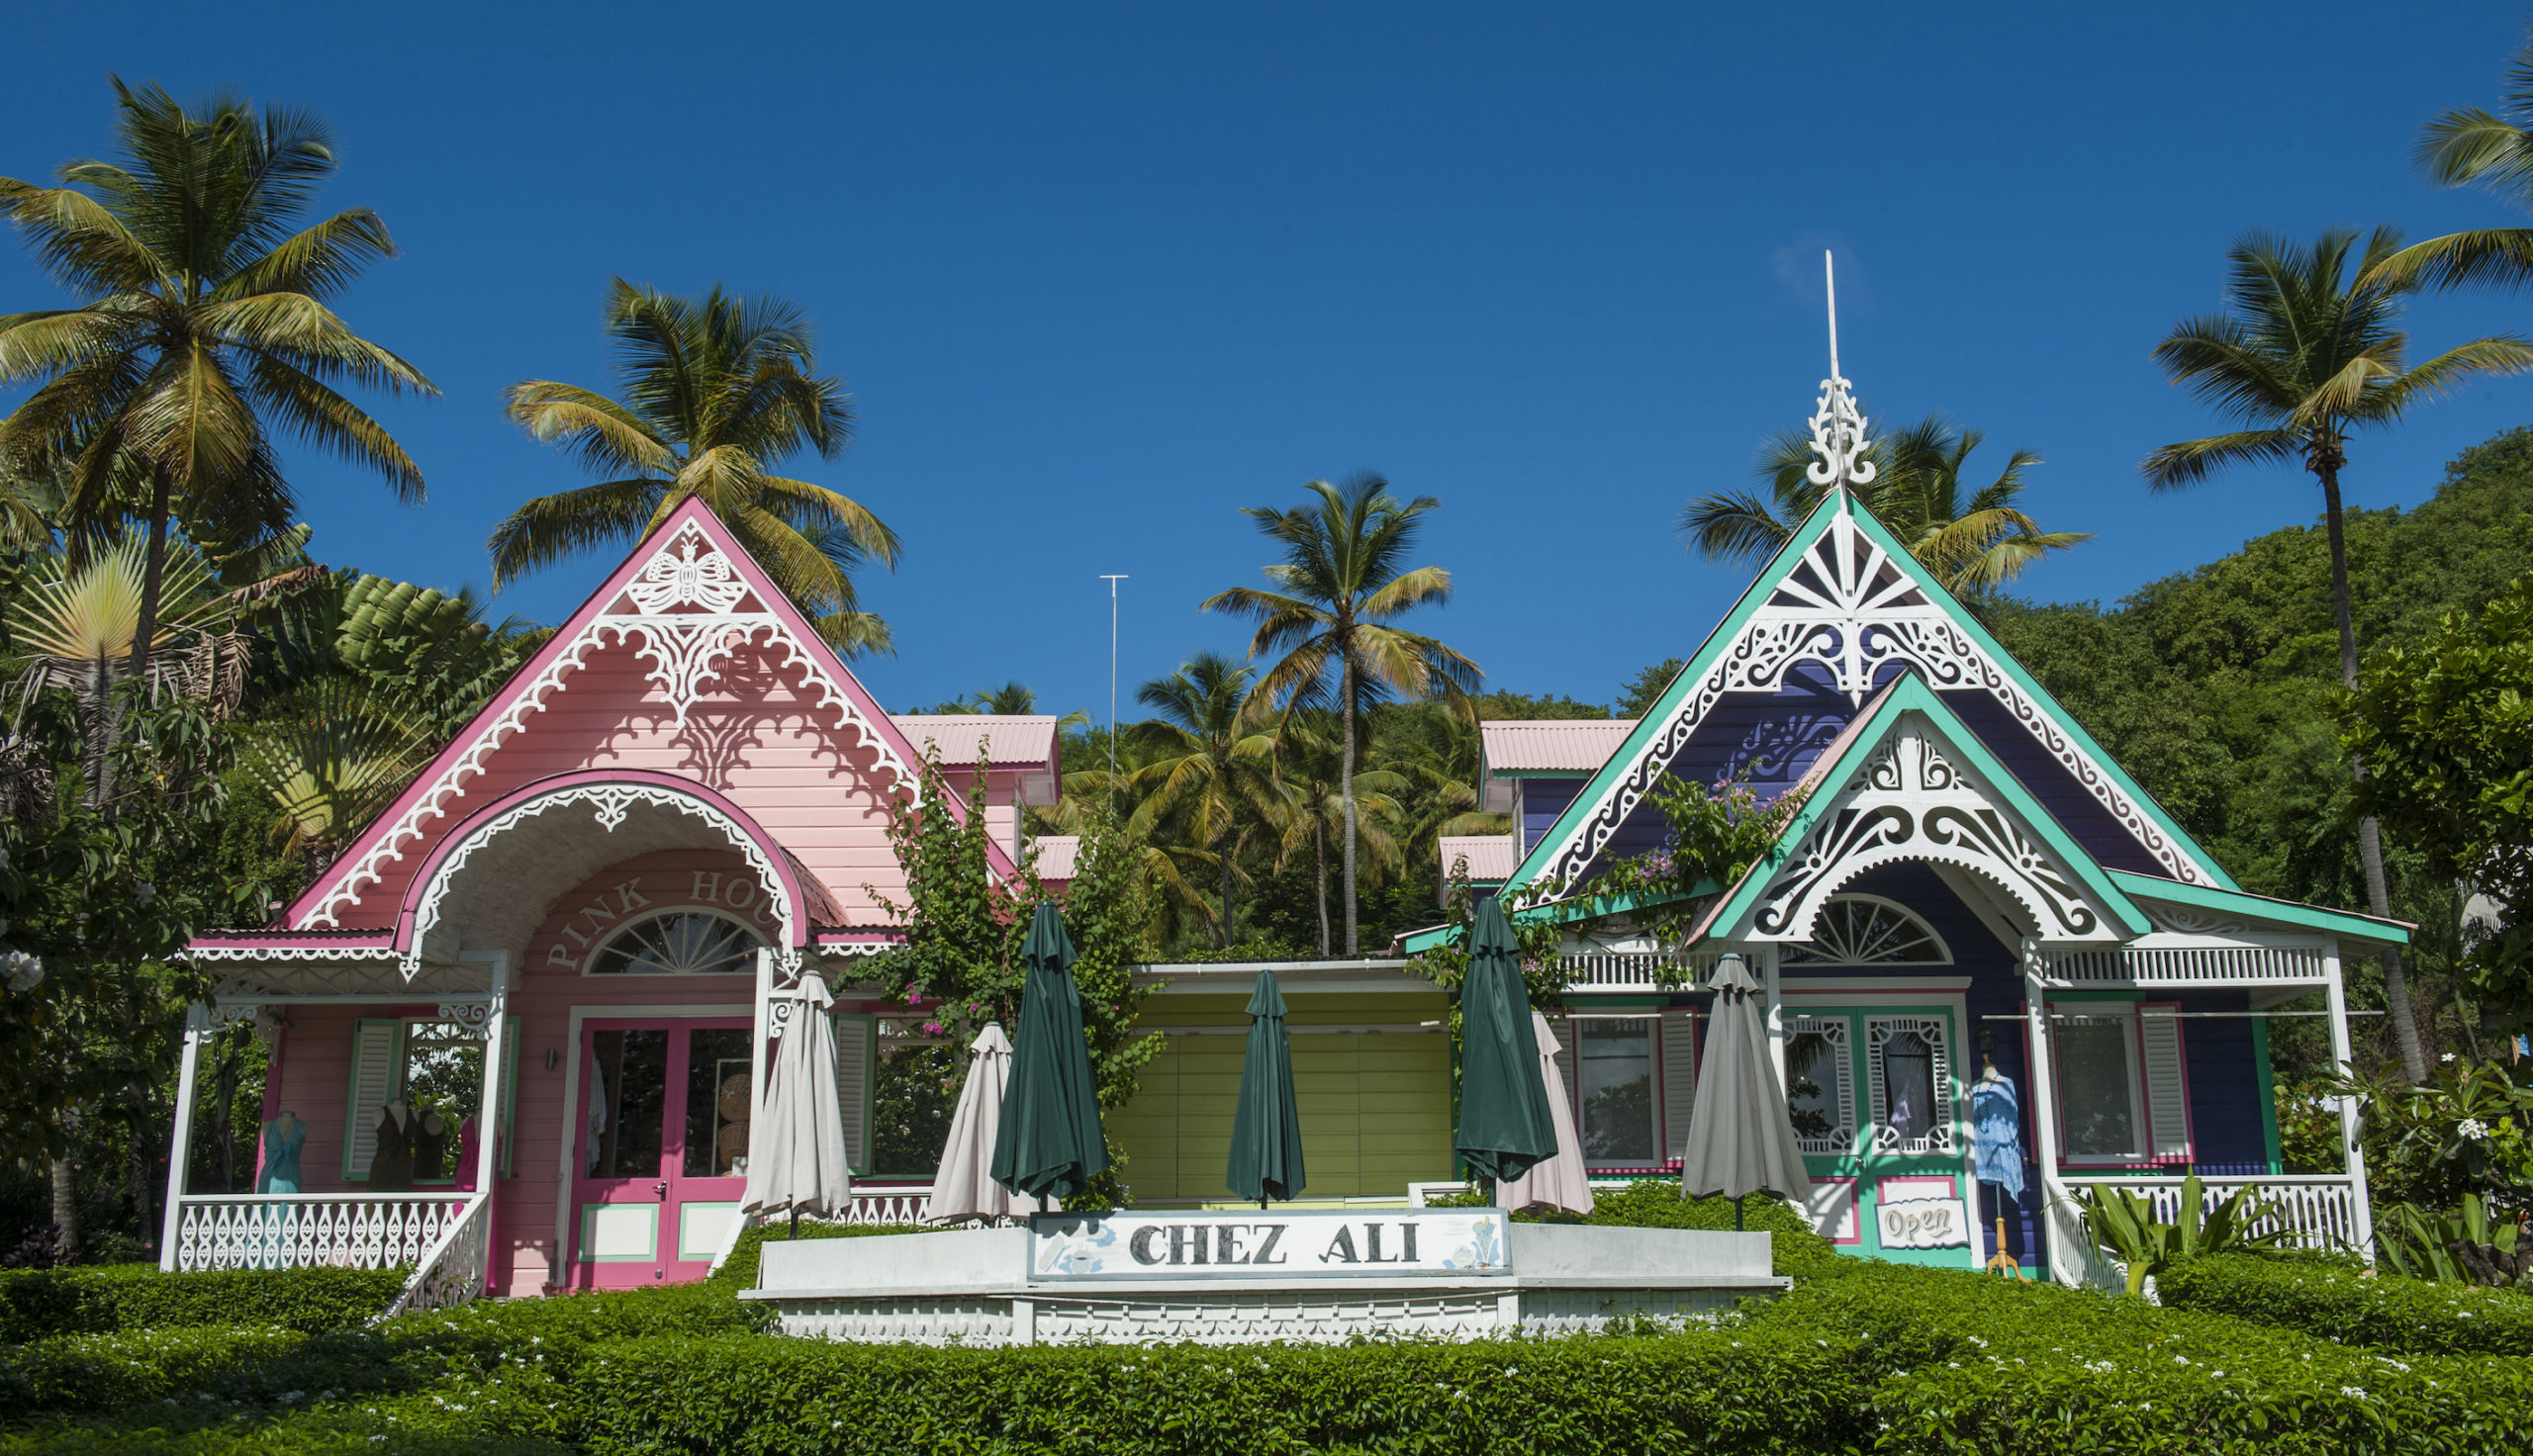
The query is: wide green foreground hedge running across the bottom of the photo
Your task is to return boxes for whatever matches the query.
[15,1258,2533,1456]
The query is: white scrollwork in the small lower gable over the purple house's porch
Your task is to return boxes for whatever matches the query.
[1718,714,2112,940]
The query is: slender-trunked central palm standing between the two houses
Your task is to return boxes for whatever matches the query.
[1200,471,1484,955]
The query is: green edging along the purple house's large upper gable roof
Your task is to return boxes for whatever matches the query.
[1507,487,2239,889]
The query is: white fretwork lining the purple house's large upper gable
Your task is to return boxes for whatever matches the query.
[1540,514,2213,883]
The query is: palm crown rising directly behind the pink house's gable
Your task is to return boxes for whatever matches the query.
[489,279,899,656]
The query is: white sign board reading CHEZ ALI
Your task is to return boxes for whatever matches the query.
[1028,1208,1512,1279]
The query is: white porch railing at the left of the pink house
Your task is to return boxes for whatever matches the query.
[159,1193,481,1271]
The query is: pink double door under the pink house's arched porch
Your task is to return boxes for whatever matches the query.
[573,1018,755,1289]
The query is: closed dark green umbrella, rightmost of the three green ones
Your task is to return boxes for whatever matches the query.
[1452,899,1557,1183]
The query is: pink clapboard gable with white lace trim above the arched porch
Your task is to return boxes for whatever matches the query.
[284,499,1016,930]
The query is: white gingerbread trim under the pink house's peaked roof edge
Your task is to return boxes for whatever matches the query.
[299,519,922,930]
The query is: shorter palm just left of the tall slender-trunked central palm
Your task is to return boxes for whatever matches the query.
[1127,653,1274,945]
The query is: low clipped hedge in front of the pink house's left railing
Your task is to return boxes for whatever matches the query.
[0,1263,406,1344]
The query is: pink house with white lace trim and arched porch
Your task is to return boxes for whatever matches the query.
[162,501,1072,1304]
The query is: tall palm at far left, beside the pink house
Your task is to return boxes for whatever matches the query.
[0,81,438,688]
